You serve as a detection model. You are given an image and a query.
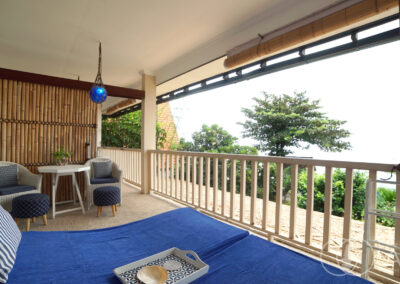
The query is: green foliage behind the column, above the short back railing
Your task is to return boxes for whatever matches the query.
[101,111,167,148]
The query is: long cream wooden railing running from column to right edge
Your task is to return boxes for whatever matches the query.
[150,151,400,283]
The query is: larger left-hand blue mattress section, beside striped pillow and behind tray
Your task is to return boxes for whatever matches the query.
[9,208,248,284]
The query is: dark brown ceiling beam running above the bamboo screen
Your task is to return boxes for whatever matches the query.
[0,68,144,100]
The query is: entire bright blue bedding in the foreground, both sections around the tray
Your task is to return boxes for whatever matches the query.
[9,208,370,284]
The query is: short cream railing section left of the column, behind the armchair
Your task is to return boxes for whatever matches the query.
[98,147,142,187]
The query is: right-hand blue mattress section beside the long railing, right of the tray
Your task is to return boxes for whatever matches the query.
[193,235,371,284]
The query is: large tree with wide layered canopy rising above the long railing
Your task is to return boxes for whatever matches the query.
[239,92,351,156]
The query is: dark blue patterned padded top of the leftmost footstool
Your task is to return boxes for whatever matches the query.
[11,193,50,218]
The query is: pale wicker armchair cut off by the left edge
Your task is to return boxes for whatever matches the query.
[0,161,42,211]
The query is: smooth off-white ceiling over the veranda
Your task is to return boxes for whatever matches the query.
[0,0,340,92]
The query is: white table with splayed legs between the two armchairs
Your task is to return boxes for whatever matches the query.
[38,165,90,219]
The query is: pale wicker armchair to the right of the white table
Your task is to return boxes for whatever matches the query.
[85,158,123,210]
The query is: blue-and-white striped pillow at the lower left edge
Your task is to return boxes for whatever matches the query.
[0,205,21,283]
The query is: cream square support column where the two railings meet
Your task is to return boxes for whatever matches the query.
[141,74,157,194]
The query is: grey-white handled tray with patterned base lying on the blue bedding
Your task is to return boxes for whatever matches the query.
[114,248,209,284]
